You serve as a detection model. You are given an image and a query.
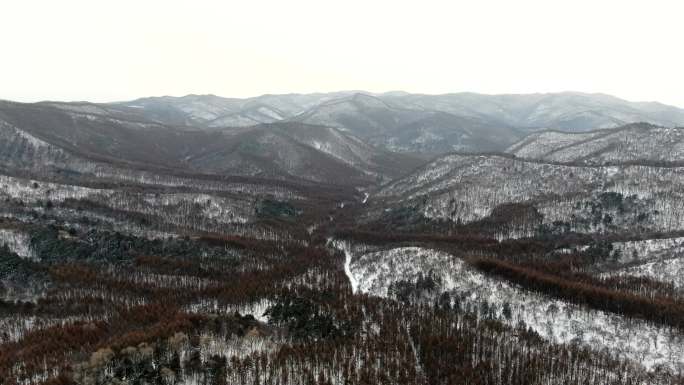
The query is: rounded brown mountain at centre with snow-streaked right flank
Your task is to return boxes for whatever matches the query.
[184,123,420,184]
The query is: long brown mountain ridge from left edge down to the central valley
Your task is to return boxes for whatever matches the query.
[0,98,418,184]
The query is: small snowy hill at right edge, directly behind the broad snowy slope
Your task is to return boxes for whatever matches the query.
[506,124,684,164]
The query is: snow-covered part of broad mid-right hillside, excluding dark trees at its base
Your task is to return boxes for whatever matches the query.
[376,154,684,231]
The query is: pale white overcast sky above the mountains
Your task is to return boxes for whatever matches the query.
[0,0,684,107]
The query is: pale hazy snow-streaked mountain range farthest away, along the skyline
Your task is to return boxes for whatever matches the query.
[120,91,684,154]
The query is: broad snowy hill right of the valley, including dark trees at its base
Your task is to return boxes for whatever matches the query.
[370,154,684,237]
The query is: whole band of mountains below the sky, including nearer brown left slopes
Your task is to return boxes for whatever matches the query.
[0,91,684,186]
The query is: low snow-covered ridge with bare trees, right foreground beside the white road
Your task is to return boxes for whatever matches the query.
[335,242,684,372]
